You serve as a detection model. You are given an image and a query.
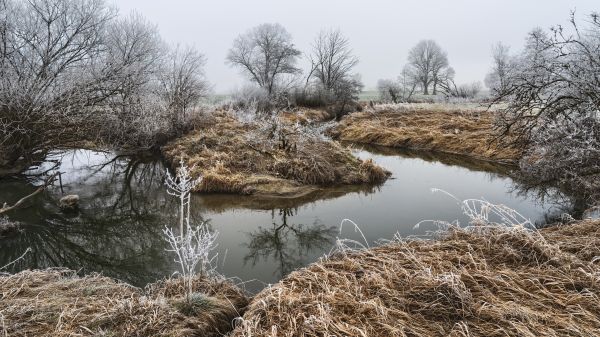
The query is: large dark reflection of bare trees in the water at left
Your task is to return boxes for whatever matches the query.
[0,153,185,285]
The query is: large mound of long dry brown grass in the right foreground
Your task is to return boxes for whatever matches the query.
[234,221,600,337]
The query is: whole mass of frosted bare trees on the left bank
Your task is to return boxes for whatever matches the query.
[0,0,211,172]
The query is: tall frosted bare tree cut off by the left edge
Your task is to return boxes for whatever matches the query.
[0,0,115,166]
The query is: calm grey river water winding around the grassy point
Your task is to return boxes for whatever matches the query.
[0,148,569,292]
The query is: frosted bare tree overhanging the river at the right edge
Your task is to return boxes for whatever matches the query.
[495,13,600,201]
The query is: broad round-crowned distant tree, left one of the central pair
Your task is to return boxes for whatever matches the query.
[227,23,301,95]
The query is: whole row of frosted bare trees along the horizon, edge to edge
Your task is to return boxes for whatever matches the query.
[0,0,600,194]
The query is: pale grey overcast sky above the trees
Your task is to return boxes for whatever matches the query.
[113,0,600,94]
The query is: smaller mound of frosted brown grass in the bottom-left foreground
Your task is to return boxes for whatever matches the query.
[0,270,248,337]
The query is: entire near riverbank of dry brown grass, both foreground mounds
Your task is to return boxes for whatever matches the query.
[5,220,600,337]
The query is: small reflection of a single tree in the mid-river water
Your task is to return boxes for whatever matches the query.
[244,208,336,278]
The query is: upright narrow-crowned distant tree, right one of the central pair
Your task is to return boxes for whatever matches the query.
[307,30,358,91]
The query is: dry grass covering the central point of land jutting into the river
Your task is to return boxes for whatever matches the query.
[163,112,389,197]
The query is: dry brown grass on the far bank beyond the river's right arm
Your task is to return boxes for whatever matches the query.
[330,104,522,163]
